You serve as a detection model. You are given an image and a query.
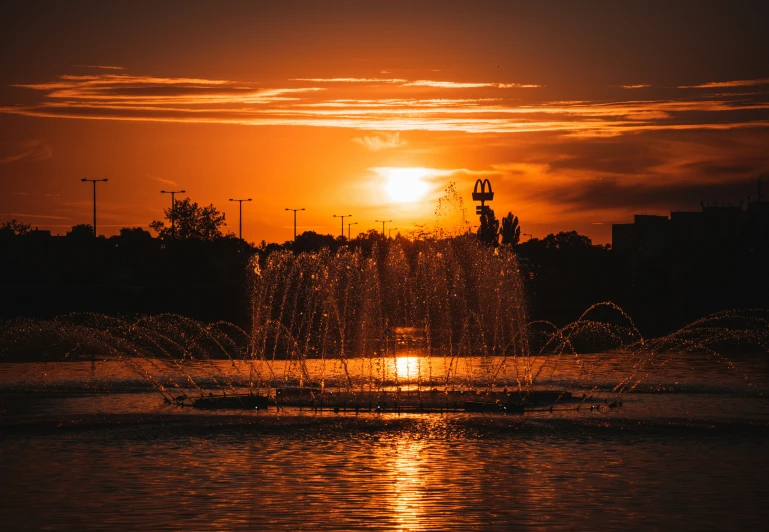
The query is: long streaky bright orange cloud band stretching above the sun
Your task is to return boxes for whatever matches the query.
[0,69,769,138]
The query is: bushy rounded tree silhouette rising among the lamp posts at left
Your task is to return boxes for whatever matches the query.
[150,198,226,241]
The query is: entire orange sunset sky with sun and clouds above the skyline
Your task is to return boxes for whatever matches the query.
[0,0,769,243]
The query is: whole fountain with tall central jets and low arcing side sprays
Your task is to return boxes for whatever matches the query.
[0,186,769,413]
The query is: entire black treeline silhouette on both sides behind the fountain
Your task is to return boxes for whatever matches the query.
[0,198,769,335]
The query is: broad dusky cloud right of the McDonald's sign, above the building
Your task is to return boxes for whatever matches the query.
[484,129,769,233]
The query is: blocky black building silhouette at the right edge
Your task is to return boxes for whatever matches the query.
[612,183,769,330]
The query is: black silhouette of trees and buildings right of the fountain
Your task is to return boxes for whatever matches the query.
[478,206,769,336]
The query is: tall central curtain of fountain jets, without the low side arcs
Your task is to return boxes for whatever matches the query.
[250,235,532,414]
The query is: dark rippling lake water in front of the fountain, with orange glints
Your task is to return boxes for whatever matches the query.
[0,358,769,530]
